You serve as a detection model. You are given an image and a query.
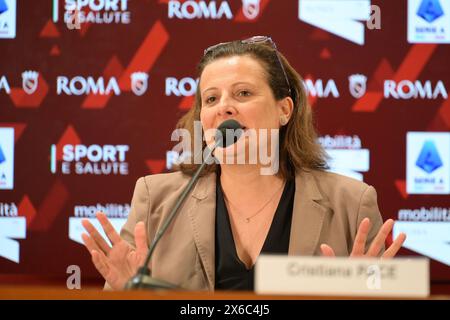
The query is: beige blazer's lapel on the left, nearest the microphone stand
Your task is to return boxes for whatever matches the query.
[188,173,216,290]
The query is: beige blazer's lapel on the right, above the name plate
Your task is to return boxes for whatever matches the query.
[289,171,330,256]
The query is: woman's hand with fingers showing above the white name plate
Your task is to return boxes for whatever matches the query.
[320,218,406,258]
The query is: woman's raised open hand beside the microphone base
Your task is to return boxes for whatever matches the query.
[81,212,148,290]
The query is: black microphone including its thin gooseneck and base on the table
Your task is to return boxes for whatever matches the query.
[125,119,243,290]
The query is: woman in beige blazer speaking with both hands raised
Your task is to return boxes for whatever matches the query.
[79,36,406,290]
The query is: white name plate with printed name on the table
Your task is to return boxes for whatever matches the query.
[255,255,430,298]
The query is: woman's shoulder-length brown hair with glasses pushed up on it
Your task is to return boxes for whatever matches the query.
[177,41,327,179]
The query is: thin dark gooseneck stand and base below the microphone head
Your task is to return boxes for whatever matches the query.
[125,139,222,290]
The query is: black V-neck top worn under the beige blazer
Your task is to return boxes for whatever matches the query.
[215,174,295,291]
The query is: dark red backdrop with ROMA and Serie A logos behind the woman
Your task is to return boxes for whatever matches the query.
[0,0,450,283]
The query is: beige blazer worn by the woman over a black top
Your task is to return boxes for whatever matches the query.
[116,171,382,290]
